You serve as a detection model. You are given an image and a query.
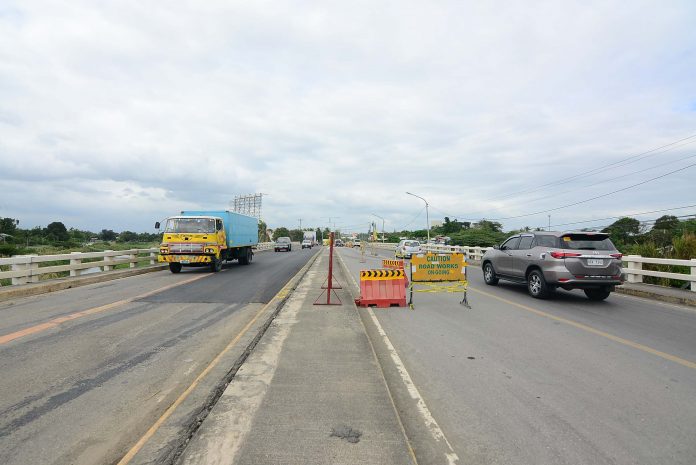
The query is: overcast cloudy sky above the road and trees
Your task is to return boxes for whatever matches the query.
[0,0,696,236]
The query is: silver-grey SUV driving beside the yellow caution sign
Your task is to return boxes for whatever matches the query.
[481,231,624,300]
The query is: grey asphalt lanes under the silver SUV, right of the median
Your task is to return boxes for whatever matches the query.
[339,245,696,465]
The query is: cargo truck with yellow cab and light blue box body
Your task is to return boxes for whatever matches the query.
[155,210,259,273]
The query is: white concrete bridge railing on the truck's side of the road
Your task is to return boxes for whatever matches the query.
[0,242,273,285]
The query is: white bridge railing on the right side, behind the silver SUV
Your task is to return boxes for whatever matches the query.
[368,243,696,292]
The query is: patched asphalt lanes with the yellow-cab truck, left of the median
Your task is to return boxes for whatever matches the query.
[0,249,317,465]
